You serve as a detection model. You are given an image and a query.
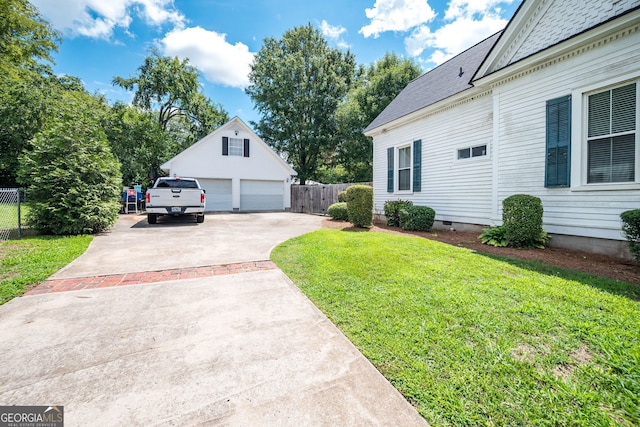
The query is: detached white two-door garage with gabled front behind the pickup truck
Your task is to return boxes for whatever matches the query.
[161,117,297,211]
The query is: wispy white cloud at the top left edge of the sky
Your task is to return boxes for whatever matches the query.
[31,0,185,39]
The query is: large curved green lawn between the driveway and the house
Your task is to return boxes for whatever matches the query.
[272,229,640,426]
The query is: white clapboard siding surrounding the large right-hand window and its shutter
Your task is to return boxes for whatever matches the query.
[493,30,640,240]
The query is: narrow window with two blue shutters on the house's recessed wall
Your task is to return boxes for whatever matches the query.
[387,140,422,193]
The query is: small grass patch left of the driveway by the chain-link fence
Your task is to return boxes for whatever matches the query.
[0,236,93,304]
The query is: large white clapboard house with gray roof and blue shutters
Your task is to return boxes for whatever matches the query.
[365,0,640,256]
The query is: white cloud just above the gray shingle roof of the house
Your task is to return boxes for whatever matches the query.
[405,16,507,64]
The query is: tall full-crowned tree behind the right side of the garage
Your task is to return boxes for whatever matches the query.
[246,24,355,184]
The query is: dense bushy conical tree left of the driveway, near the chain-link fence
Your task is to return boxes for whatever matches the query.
[18,90,121,235]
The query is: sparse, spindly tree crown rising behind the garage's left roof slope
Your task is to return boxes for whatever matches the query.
[113,49,229,137]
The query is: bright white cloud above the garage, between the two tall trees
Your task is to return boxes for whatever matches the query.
[161,27,254,88]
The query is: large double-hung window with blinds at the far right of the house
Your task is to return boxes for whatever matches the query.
[587,83,637,184]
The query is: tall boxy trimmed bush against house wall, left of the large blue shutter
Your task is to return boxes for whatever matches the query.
[502,194,546,248]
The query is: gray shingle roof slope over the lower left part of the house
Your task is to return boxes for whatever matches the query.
[365,31,502,132]
